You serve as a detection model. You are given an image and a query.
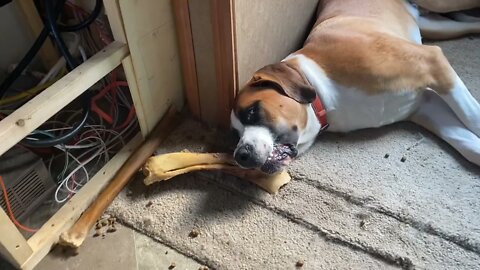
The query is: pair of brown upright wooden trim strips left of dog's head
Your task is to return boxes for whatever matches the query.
[172,0,238,128]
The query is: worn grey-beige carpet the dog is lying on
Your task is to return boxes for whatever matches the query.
[109,37,480,269]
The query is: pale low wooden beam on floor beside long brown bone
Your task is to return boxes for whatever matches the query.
[22,134,142,269]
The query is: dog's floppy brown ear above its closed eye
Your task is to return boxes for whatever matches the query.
[249,62,316,104]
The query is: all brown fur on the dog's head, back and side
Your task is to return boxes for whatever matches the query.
[236,0,462,128]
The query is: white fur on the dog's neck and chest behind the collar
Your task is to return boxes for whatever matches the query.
[292,55,421,132]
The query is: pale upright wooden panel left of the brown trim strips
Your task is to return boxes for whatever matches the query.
[118,0,184,134]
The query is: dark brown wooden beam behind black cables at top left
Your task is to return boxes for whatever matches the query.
[14,0,60,70]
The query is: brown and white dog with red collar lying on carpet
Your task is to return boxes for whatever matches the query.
[231,0,480,173]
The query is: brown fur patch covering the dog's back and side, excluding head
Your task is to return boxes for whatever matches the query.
[297,0,454,94]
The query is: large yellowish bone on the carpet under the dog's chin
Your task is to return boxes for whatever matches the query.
[143,152,291,193]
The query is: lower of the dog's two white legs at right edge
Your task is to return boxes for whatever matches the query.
[410,90,480,166]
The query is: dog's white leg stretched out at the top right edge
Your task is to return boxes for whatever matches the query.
[418,14,480,40]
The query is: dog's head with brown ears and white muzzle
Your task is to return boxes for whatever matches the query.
[231,62,316,174]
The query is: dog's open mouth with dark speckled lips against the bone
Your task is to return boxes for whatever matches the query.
[260,143,298,174]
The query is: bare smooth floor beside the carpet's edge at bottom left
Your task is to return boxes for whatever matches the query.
[0,225,202,270]
